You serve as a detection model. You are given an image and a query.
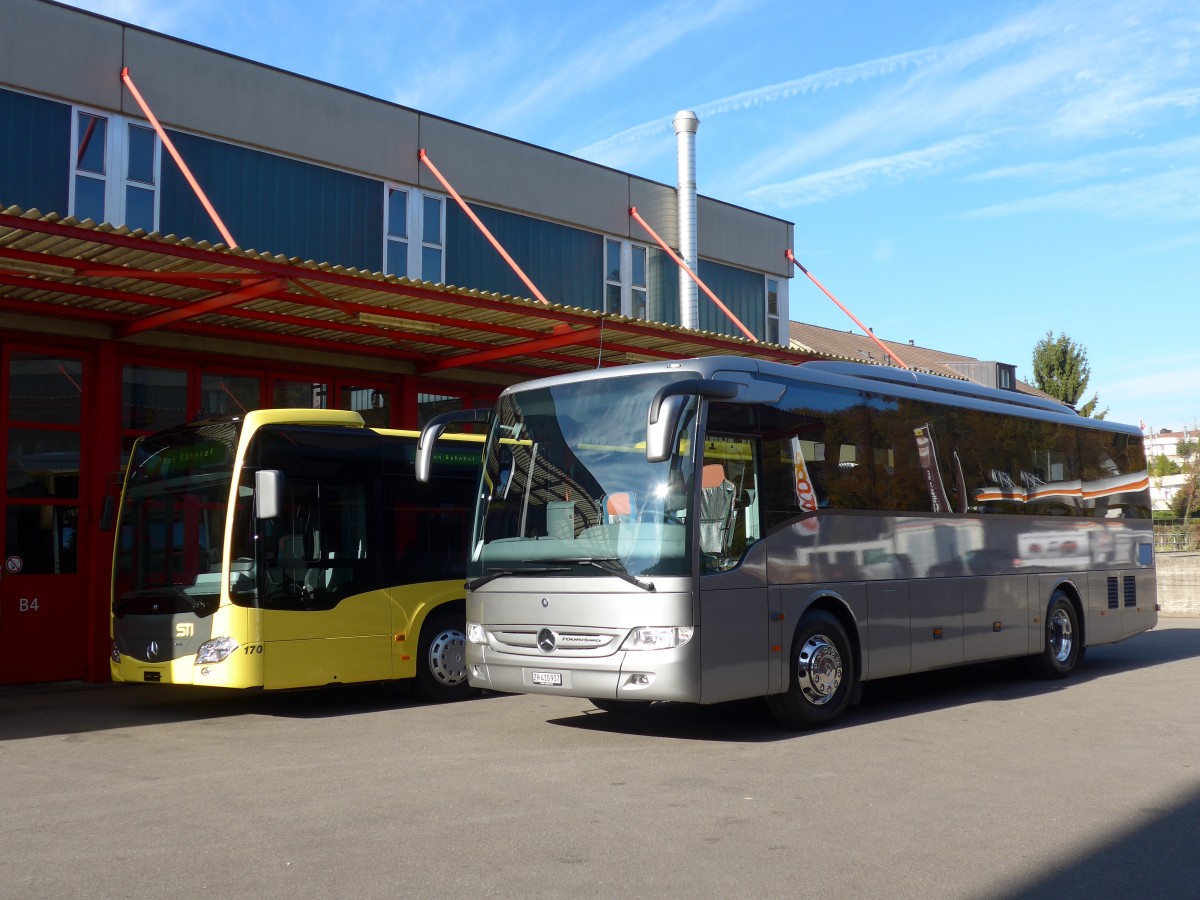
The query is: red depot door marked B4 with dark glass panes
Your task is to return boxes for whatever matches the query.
[0,348,89,684]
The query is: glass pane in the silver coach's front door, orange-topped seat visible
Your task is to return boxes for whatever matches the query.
[700,403,762,571]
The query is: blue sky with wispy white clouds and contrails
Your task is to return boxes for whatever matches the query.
[63,0,1200,431]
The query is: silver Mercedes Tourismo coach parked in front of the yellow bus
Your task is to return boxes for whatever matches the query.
[418,356,1157,728]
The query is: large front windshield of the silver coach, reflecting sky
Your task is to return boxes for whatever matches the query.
[468,373,696,580]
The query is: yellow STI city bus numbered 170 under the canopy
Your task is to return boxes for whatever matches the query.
[110,409,482,700]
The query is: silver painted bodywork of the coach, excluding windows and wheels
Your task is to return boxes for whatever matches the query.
[467,356,1157,703]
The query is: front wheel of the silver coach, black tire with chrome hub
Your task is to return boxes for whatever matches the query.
[767,610,856,731]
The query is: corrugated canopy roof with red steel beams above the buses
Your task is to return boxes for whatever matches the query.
[0,206,860,377]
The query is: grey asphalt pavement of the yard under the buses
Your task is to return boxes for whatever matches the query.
[0,618,1200,900]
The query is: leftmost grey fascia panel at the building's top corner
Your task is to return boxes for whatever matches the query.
[0,0,124,111]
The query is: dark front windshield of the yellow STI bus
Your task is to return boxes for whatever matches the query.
[114,421,240,612]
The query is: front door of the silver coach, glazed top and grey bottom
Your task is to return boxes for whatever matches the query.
[695,427,772,703]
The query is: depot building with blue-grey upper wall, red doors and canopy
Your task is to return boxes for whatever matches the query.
[0,0,820,684]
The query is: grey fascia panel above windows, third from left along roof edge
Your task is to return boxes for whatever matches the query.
[419,116,629,234]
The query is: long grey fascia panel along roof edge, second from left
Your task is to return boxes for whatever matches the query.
[121,29,418,184]
